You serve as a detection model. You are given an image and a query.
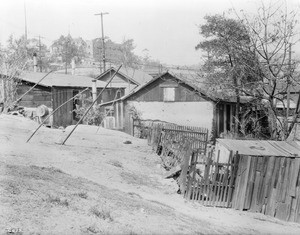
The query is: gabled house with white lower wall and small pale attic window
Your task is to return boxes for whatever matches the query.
[100,71,251,137]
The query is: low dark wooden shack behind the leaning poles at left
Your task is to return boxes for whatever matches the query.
[4,72,125,127]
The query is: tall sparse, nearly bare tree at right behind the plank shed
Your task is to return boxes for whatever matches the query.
[241,1,300,140]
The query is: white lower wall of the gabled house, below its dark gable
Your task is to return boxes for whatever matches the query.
[129,101,214,131]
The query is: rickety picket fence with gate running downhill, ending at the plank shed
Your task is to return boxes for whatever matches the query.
[142,121,238,207]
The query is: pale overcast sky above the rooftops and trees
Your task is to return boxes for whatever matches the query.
[0,0,300,65]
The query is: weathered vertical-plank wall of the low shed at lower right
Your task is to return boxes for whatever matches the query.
[232,156,300,223]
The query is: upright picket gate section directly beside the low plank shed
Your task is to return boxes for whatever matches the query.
[181,151,238,207]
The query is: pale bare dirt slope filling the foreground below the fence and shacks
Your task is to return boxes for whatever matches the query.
[0,114,300,234]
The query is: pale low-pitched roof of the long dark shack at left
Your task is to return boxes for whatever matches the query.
[19,72,126,88]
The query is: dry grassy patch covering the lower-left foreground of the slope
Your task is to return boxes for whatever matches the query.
[0,164,220,234]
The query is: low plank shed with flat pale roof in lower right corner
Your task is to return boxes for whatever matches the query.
[217,139,300,223]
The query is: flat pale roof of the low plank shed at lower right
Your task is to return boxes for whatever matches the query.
[217,139,300,157]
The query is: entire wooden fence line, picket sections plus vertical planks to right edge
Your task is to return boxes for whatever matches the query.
[134,118,300,223]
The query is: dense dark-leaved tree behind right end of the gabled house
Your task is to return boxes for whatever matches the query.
[196,15,259,132]
